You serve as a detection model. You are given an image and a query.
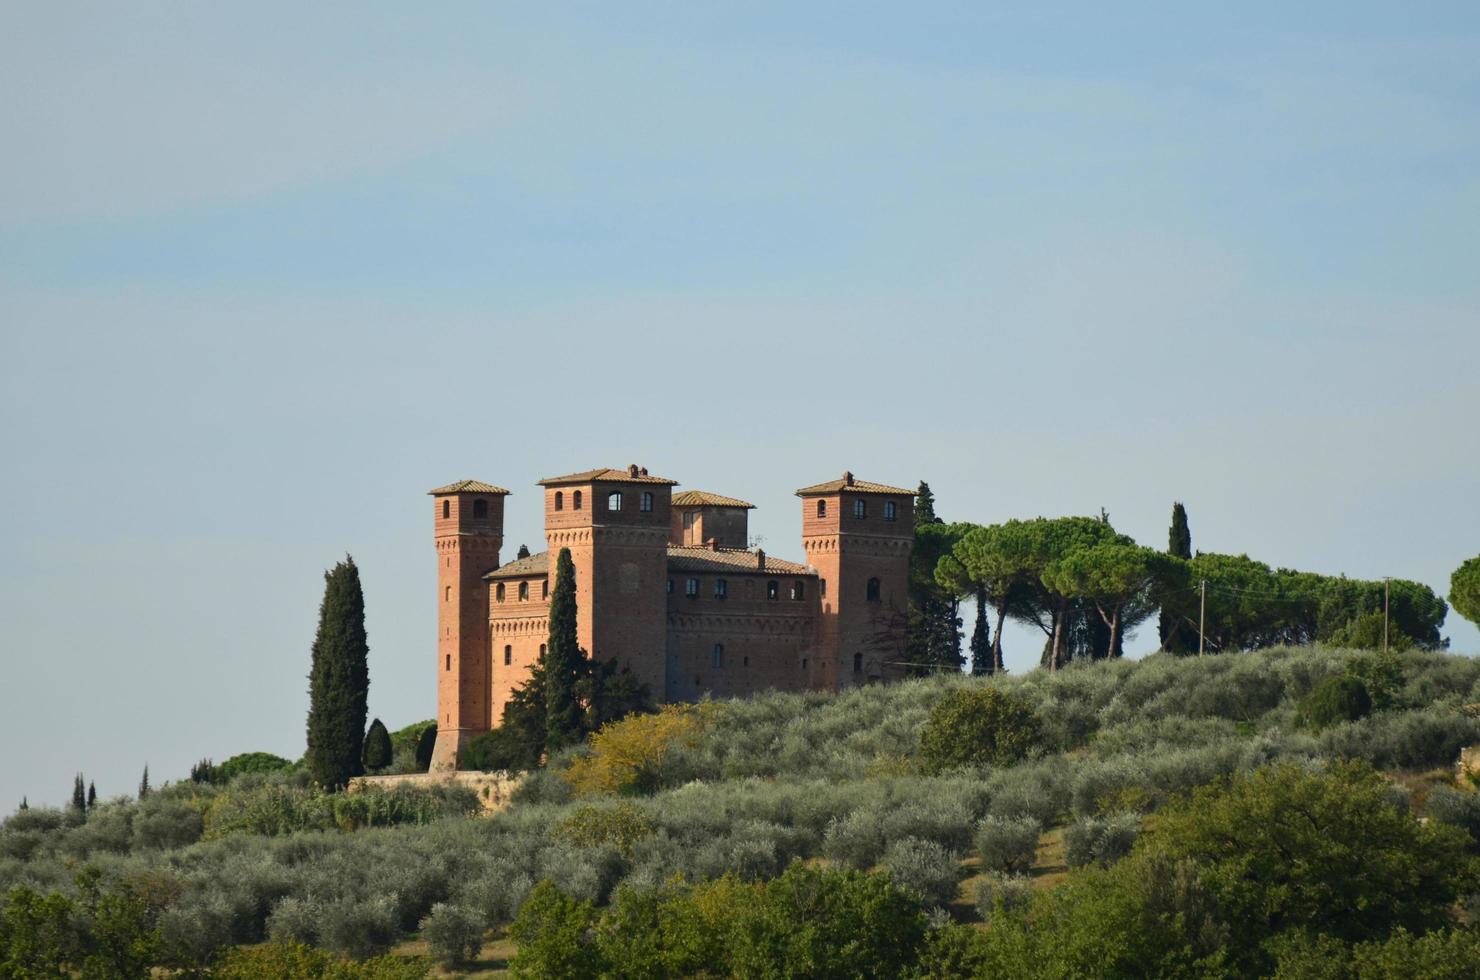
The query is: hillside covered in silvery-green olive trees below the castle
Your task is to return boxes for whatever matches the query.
[0,648,1480,976]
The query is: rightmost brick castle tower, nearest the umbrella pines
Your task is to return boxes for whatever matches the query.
[796,472,915,690]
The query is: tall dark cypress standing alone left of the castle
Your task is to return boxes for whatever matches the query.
[305,555,370,789]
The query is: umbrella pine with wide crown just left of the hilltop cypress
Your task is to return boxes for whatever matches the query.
[1043,540,1185,656]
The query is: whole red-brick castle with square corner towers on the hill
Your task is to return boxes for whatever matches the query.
[431,466,915,770]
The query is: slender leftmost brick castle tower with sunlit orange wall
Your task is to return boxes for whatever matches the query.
[431,480,509,770]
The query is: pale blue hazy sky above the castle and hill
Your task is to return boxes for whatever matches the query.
[0,0,1480,811]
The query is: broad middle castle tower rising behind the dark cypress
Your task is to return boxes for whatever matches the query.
[540,466,675,699]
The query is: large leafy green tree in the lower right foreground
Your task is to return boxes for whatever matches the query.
[1154,762,1474,967]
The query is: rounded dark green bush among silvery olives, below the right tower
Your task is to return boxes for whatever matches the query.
[921,687,1042,773]
